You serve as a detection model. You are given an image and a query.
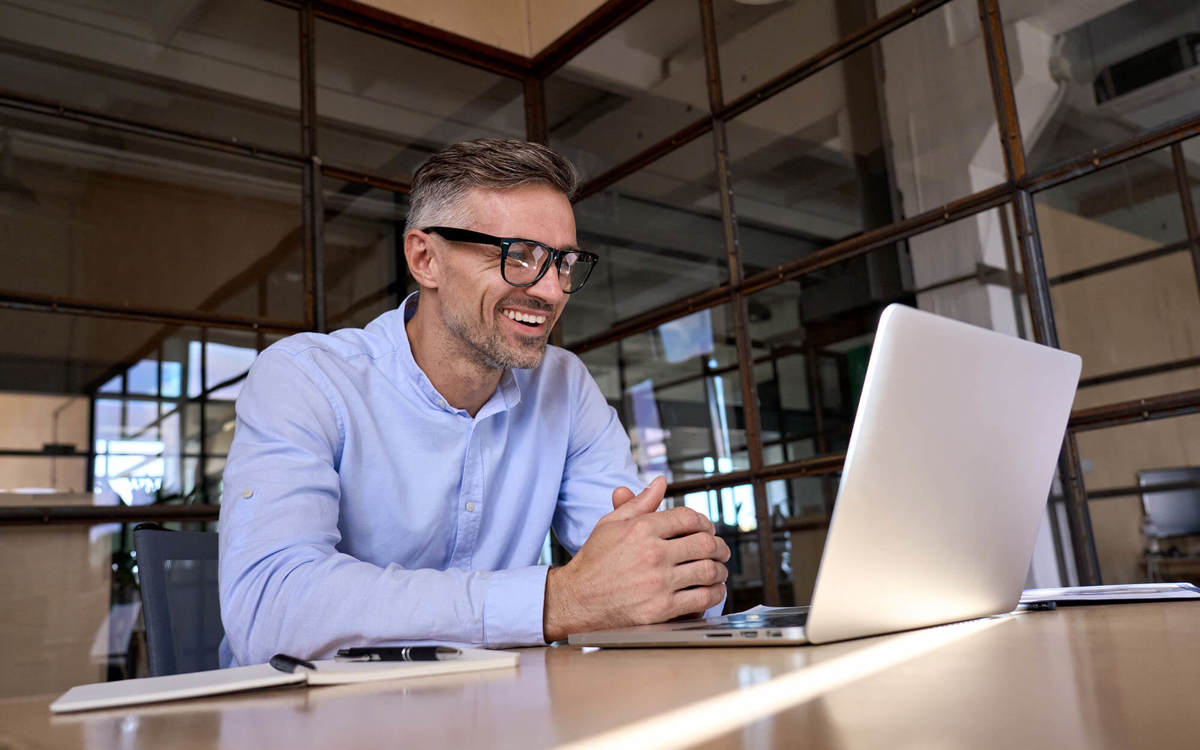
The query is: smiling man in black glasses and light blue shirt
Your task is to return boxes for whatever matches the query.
[221,140,730,666]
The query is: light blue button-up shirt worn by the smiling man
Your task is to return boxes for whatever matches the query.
[220,295,640,666]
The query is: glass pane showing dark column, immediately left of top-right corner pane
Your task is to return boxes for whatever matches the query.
[728,0,1004,269]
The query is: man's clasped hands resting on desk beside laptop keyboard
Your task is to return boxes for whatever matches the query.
[542,476,730,642]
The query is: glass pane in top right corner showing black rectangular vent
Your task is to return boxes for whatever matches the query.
[1000,0,1200,172]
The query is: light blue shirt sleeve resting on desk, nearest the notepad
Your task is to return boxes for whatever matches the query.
[220,349,547,665]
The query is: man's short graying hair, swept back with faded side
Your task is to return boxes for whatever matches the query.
[404,138,578,234]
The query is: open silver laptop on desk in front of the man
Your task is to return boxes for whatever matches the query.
[569,305,1081,647]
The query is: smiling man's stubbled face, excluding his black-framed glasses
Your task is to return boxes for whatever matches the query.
[434,185,576,368]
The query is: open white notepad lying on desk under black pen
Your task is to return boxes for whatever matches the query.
[50,648,520,714]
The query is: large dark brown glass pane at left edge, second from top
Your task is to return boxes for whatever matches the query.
[0,110,304,320]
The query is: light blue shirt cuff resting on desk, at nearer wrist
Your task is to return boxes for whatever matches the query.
[484,565,550,648]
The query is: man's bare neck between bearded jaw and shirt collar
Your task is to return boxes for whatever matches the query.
[404,296,504,416]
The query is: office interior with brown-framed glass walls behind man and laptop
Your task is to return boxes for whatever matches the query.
[0,0,1200,697]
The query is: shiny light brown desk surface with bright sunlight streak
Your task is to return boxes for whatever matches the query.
[0,602,1200,750]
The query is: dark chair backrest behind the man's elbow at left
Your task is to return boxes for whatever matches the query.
[133,523,224,677]
